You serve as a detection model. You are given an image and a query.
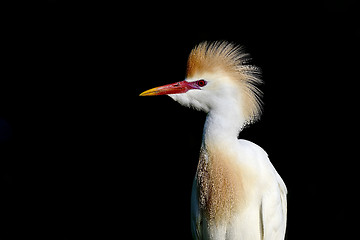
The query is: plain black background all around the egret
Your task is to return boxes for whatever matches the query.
[0,1,359,239]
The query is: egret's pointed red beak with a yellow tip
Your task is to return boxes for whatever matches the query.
[140,81,199,96]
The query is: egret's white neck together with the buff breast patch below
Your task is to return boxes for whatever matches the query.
[196,105,245,225]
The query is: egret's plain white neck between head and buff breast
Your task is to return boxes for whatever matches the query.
[203,104,245,144]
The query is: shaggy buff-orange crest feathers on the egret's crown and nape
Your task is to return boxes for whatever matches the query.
[186,41,262,123]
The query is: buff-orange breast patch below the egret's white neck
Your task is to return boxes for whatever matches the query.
[196,144,252,223]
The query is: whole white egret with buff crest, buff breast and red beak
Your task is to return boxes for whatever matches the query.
[140,40,287,240]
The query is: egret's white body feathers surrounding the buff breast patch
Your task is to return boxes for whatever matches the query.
[191,137,287,240]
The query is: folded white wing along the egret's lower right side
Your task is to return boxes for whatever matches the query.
[260,169,287,240]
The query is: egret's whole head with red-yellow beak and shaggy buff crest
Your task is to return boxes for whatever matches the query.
[140,41,261,122]
